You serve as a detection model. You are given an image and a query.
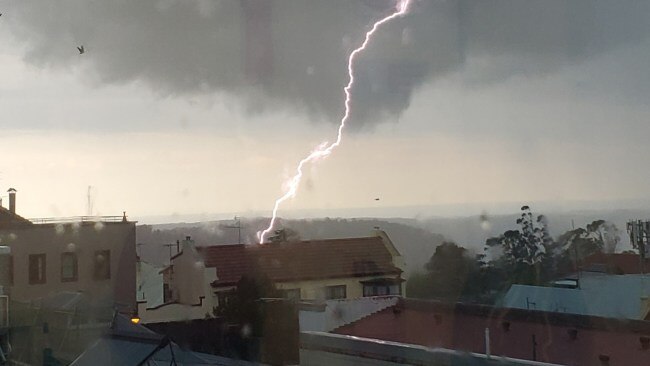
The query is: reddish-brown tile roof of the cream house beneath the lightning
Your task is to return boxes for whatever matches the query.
[197,237,402,286]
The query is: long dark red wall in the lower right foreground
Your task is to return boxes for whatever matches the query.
[335,308,650,366]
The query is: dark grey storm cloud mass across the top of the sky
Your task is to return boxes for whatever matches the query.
[3,0,650,126]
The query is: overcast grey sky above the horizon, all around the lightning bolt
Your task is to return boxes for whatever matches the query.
[0,0,650,217]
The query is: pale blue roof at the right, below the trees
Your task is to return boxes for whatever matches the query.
[503,274,650,319]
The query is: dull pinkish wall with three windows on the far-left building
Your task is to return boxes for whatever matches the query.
[0,222,136,312]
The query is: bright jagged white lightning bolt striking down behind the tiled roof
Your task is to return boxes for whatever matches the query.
[259,0,411,244]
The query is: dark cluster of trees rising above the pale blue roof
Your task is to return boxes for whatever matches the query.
[406,206,621,304]
